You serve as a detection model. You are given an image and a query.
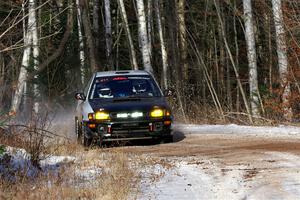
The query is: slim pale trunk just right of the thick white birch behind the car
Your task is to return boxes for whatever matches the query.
[154,0,168,89]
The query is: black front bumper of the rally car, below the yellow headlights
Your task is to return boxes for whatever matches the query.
[86,119,172,141]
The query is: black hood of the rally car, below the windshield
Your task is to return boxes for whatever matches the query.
[89,97,169,112]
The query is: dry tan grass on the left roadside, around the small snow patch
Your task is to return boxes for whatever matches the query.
[0,115,139,200]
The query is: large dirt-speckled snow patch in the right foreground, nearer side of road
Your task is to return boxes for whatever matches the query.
[138,152,300,200]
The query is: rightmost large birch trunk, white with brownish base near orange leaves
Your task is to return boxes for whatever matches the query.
[272,0,292,120]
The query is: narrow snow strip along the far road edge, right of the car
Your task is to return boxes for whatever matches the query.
[173,124,300,137]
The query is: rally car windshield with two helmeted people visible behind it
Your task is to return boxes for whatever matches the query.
[90,76,162,99]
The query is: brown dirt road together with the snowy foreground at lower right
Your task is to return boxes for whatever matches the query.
[114,132,300,199]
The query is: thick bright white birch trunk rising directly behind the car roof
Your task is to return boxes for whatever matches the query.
[136,0,153,73]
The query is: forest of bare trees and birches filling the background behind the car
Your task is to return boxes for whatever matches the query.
[0,0,300,124]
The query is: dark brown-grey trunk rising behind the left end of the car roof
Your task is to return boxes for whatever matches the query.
[79,0,100,72]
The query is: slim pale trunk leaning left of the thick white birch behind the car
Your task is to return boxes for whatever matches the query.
[118,0,139,70]
